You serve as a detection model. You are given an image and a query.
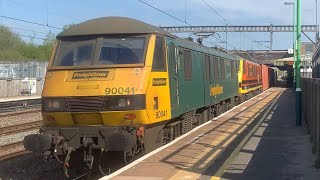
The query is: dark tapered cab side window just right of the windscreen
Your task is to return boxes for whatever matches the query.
[152,36,166,71]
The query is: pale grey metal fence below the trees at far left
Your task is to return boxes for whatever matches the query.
[0,61,48,79]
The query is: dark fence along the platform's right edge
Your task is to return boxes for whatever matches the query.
[301,78,320,168]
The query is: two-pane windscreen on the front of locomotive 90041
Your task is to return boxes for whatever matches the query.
[53,36,147,66]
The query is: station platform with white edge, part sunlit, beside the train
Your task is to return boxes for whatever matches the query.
[101,88,320,180]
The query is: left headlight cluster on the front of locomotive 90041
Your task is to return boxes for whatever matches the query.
[42,98,66,112]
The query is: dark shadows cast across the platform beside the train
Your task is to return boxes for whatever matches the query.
[161,89,320,180]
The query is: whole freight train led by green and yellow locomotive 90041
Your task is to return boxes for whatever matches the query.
[24,17,276,176]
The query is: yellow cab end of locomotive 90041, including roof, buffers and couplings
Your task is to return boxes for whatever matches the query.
[24,18,170,175]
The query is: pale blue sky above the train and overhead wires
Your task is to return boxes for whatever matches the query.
[0,0,320,50]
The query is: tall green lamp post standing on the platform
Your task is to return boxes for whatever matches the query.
[294,0,302,126]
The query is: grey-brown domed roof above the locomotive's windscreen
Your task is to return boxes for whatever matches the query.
[57,17,176,38]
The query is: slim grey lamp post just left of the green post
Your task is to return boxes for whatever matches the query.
[284,2,296,89]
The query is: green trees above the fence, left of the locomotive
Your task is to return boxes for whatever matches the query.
[0,26,55,61]
